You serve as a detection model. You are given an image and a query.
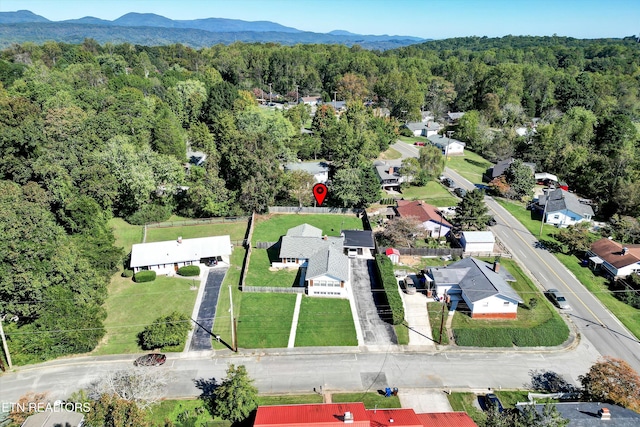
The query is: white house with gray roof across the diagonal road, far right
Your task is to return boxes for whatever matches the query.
[534,188,594,227]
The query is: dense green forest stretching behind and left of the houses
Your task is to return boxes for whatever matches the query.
[0,37,640,360]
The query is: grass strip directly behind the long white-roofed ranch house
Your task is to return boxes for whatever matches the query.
[147,221,247,242]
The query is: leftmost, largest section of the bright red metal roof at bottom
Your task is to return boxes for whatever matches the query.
[253,402,370,427]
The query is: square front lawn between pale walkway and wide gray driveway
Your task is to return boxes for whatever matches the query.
[295,296,358,347]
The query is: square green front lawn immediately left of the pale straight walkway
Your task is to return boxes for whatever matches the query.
[238,293,296,348]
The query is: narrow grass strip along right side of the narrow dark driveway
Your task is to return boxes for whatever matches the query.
[212,246,246,350]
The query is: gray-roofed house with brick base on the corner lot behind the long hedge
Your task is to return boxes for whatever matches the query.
[428,257,523,319]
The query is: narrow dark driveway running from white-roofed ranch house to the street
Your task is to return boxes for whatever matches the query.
[189,268,228,351]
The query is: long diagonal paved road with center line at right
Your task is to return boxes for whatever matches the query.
[445,168,640,372]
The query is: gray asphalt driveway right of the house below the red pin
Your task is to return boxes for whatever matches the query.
[351,258,397,345]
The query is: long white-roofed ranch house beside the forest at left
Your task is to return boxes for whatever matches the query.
[130,236,233,275]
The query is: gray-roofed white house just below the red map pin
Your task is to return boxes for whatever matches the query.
[271,224,351,298]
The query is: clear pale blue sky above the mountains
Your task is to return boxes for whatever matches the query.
[0,0,640,39]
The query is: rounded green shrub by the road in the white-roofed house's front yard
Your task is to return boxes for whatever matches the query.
[138,311,191,350]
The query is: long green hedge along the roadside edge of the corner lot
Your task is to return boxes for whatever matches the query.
[453,316,569,347]
